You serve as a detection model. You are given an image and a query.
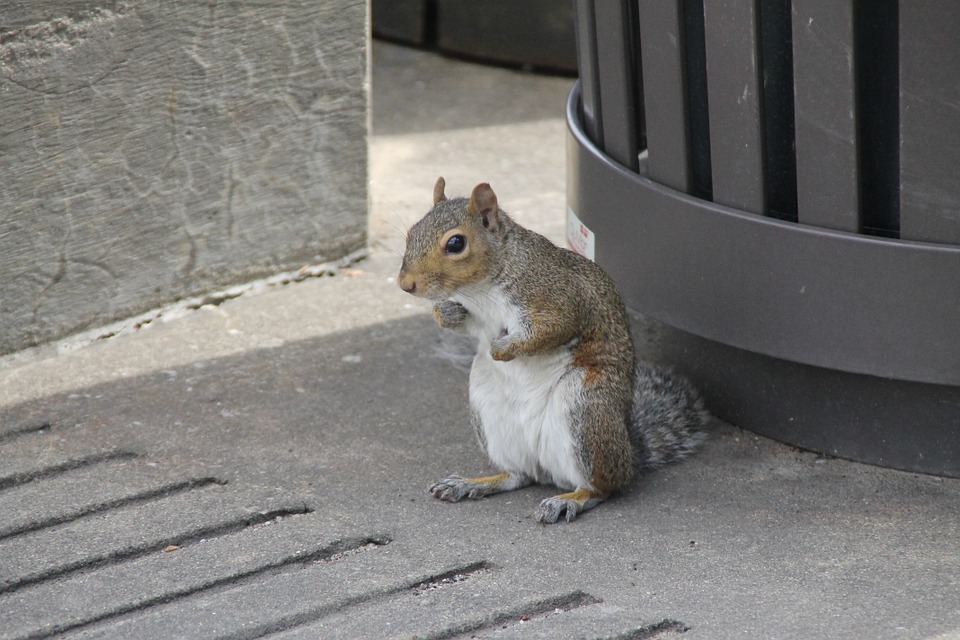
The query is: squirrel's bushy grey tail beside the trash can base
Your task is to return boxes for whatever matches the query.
[627,362,710,473]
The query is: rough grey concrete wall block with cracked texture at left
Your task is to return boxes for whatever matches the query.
[0,0,367,353]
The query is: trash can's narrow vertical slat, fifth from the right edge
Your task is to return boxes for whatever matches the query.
[594,0,640,171]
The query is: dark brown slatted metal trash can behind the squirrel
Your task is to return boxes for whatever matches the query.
[567,0,960,477]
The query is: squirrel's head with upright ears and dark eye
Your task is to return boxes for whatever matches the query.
[397,178,502,300]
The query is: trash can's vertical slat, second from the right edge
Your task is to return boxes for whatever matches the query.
[793,0,860,232]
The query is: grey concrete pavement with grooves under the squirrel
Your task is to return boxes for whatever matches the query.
[0,43,960,639]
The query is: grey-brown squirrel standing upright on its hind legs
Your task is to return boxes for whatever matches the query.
[397,177,709,523]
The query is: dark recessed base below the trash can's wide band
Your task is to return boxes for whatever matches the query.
[634,316,960,478]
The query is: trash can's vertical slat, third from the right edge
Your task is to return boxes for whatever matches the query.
[703,0,766,214]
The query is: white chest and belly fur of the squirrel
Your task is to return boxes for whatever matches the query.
[455,284,590,489]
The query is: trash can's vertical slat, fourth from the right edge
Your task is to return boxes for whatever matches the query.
[638,0,692,193]
